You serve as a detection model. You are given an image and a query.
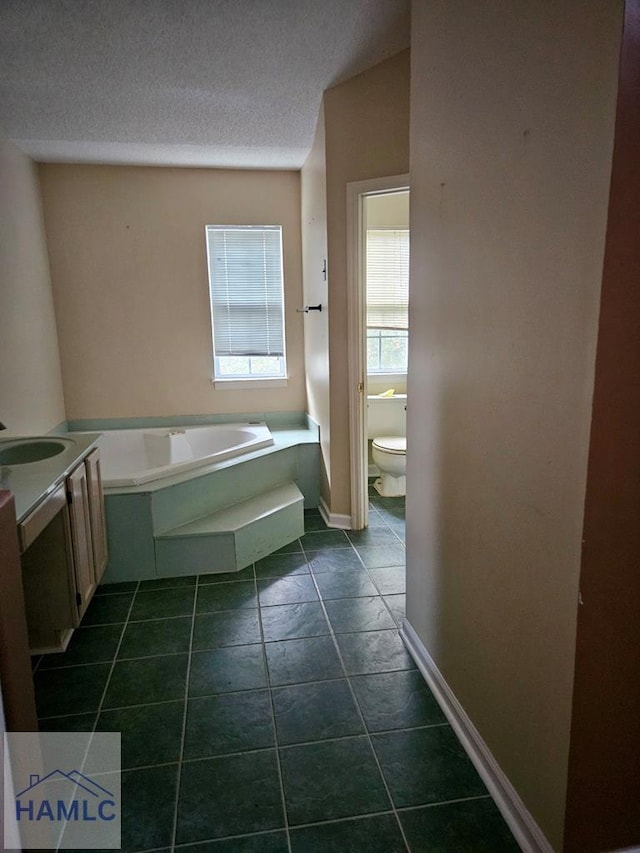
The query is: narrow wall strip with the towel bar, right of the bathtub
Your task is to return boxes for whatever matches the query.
[300,107,331,502]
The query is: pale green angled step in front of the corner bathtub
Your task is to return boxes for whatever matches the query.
[155,483,304,577]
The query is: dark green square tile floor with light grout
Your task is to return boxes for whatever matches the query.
[35,495,519,853]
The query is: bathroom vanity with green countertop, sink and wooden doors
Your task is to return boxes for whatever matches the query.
[0,434,107,654]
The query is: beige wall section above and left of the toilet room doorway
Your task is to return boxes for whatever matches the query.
[324,51,409,515]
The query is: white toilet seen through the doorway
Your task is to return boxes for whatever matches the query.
[367,394,407,498]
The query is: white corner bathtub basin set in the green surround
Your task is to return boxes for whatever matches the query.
[100,424,273,488]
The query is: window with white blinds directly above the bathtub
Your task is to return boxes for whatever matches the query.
[206,225,286,379]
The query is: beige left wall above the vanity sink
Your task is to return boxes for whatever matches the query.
[0,136,65,436]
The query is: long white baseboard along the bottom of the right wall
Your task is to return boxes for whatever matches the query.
[400,620,553,853]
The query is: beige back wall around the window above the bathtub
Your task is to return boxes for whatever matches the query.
[40,165,306,420]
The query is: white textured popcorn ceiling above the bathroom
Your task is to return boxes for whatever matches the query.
[0,0,410,168]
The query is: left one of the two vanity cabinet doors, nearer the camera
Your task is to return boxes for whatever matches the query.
[67,465,96,626]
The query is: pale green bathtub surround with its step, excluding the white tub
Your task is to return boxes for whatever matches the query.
[86,416,320,582]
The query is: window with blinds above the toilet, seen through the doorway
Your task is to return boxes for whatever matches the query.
[366,229,409,373]
